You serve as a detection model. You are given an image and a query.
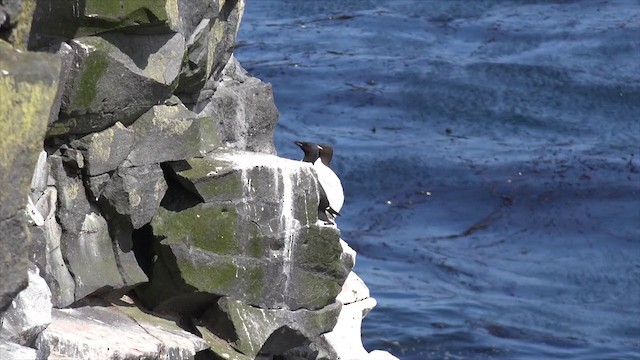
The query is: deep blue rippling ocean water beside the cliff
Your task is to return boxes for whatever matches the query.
[235,0,640,359]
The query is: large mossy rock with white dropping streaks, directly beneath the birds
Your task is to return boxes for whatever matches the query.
[140,152,350,309]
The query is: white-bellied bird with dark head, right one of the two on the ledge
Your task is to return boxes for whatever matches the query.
[313,144,344,219]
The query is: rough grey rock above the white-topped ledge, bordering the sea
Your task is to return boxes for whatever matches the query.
[195,57,279,154]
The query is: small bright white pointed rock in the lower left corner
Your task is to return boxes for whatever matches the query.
[0,266,52,346]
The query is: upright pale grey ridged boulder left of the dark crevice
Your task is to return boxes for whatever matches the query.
[44,153,147,307]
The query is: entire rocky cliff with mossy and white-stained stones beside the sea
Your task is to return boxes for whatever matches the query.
[0,0,390,360]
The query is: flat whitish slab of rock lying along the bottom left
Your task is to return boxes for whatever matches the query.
[36,304,207,359]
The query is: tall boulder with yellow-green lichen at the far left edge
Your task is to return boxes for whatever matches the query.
[0,40,60,311]
